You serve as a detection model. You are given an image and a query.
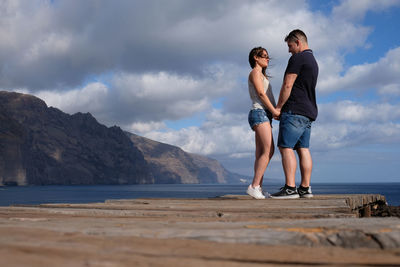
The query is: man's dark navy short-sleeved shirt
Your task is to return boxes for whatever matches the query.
[282,49,318,121]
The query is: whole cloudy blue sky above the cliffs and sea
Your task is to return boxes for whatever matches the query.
[0,0,400,183]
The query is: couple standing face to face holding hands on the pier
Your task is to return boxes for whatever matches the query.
[247,29,318,199]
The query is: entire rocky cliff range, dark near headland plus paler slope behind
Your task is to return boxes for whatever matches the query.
[0,91,239,185]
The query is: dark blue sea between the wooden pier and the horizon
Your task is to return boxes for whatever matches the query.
[0,183,400,206]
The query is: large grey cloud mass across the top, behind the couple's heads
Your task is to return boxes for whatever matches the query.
[0,0,376,91]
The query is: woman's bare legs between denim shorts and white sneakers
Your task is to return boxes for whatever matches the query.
[252,122,274,187]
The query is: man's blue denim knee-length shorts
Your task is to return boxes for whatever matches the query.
[278,112,312,149]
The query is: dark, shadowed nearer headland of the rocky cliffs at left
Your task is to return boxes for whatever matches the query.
[0,92,154,185]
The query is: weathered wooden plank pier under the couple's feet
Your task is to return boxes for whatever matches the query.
[0,195,400,267]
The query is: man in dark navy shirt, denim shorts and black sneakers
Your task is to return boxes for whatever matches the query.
[271,29,318,199]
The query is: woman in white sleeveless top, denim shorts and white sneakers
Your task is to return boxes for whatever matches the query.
[247,47,279,199]
